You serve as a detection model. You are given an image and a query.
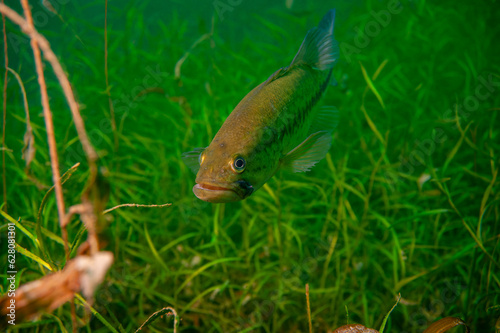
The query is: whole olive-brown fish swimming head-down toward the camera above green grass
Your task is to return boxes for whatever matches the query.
[182,9,339,203]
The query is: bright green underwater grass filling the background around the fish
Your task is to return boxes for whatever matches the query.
[0,1,500,332]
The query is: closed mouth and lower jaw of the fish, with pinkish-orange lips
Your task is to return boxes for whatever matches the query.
[193,180,253,203]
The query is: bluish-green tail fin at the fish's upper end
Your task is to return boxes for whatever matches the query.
[290,9,339,71]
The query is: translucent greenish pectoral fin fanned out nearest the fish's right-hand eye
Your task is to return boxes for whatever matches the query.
[281,131,332,172]
